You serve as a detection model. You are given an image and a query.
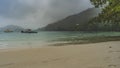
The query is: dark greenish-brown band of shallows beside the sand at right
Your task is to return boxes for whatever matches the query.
[51,36,120,46]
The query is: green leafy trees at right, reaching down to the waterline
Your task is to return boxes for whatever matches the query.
[87,0,120,31]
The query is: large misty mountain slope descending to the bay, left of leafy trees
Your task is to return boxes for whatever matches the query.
[39,8,101,31]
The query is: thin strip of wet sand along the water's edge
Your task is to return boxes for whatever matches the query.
[0,40,120,52]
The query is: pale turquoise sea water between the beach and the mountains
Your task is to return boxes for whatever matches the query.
[0,31,120,49]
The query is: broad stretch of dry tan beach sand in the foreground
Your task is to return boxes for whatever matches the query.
[0,41,120,68]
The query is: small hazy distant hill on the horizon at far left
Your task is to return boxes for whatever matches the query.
[0,25,24,32]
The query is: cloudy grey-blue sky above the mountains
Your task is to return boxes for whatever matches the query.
[0,0,93,29]
